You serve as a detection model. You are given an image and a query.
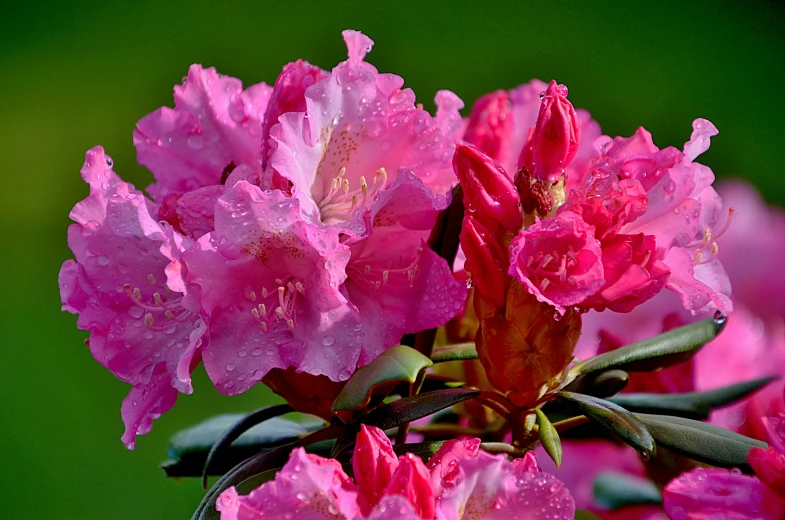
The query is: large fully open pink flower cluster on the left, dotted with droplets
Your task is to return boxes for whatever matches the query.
[60,31,466,447]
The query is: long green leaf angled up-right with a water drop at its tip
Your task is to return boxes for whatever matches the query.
[570,318,727,377]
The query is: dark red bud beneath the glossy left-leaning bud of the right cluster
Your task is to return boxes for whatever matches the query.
[461,215,508,309]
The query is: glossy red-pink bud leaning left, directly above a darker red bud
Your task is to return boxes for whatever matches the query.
[452,144,523,233]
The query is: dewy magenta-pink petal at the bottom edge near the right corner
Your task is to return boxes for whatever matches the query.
[662,468,772,520]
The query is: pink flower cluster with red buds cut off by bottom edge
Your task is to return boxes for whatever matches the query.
[217,427,575,520]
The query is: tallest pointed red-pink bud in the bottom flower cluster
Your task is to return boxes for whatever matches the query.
[352,424,398,510]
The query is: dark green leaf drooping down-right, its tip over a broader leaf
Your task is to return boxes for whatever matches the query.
[557,392,656,458]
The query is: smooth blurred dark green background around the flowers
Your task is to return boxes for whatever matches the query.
[0,0,785,519]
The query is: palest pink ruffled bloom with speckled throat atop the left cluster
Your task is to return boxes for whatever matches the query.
[270,31,459,235]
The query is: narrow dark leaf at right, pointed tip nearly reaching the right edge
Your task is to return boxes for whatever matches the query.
[608,377,776,419]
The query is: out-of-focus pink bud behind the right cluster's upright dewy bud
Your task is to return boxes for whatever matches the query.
[463,90,514,167]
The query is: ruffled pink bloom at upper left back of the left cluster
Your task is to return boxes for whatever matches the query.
[134,65,271,201]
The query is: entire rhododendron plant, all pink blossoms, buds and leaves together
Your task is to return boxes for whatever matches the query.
[59,27,785,520]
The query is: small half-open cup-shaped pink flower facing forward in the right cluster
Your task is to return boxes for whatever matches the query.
[509,211,604,314]
